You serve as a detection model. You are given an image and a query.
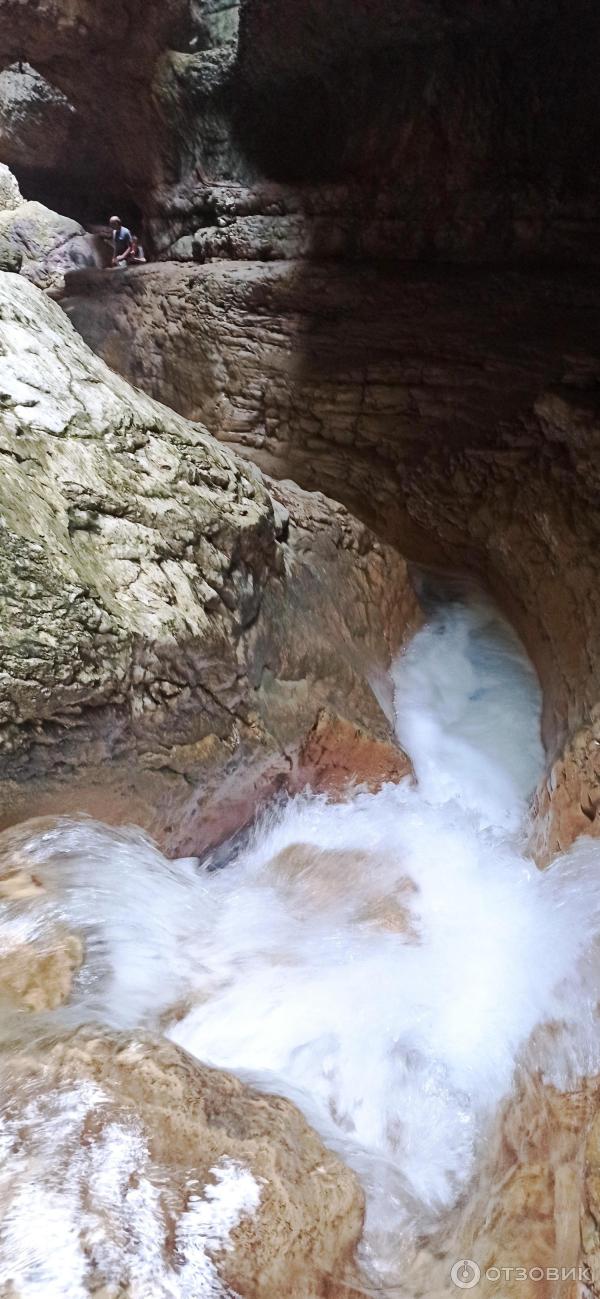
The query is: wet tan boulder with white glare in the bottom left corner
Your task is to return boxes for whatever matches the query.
[0,820,364,1299]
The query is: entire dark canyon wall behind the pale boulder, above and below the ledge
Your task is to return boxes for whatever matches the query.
[0,0,600,860]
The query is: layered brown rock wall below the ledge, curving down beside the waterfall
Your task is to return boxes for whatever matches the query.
[59,261,600,861]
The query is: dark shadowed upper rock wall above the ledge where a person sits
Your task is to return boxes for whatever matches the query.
[0,0,600,264]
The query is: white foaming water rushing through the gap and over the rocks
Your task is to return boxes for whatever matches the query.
[0,604,600,1299]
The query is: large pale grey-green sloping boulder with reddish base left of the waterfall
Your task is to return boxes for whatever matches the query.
[0,275,418,853]
